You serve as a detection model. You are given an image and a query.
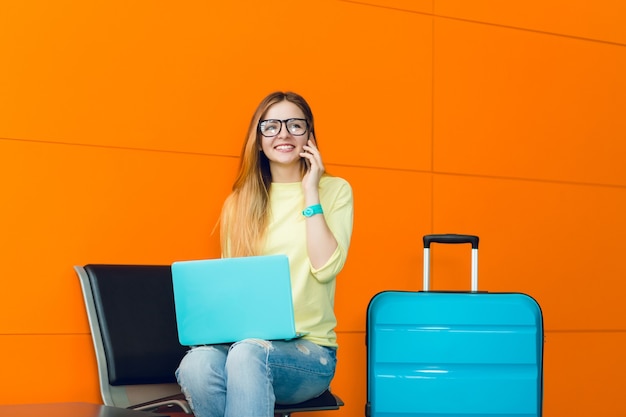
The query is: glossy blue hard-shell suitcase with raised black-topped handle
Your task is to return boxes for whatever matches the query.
[365,235,544,417]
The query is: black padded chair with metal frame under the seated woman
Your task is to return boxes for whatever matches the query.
[74,264,343,417]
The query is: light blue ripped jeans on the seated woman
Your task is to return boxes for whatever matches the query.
[176,339,337,417]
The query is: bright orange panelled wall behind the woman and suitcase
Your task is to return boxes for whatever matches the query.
[0,0,626,417]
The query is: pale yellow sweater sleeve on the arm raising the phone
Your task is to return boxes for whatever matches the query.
[311,177,354,283]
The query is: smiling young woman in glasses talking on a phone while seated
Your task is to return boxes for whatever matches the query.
[176,92,353,417]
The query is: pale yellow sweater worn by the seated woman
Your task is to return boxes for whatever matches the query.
[263,175,353,347]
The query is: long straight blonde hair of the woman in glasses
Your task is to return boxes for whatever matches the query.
[220,91,315,257]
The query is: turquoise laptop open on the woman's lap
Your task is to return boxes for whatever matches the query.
[172,255,302,346]
